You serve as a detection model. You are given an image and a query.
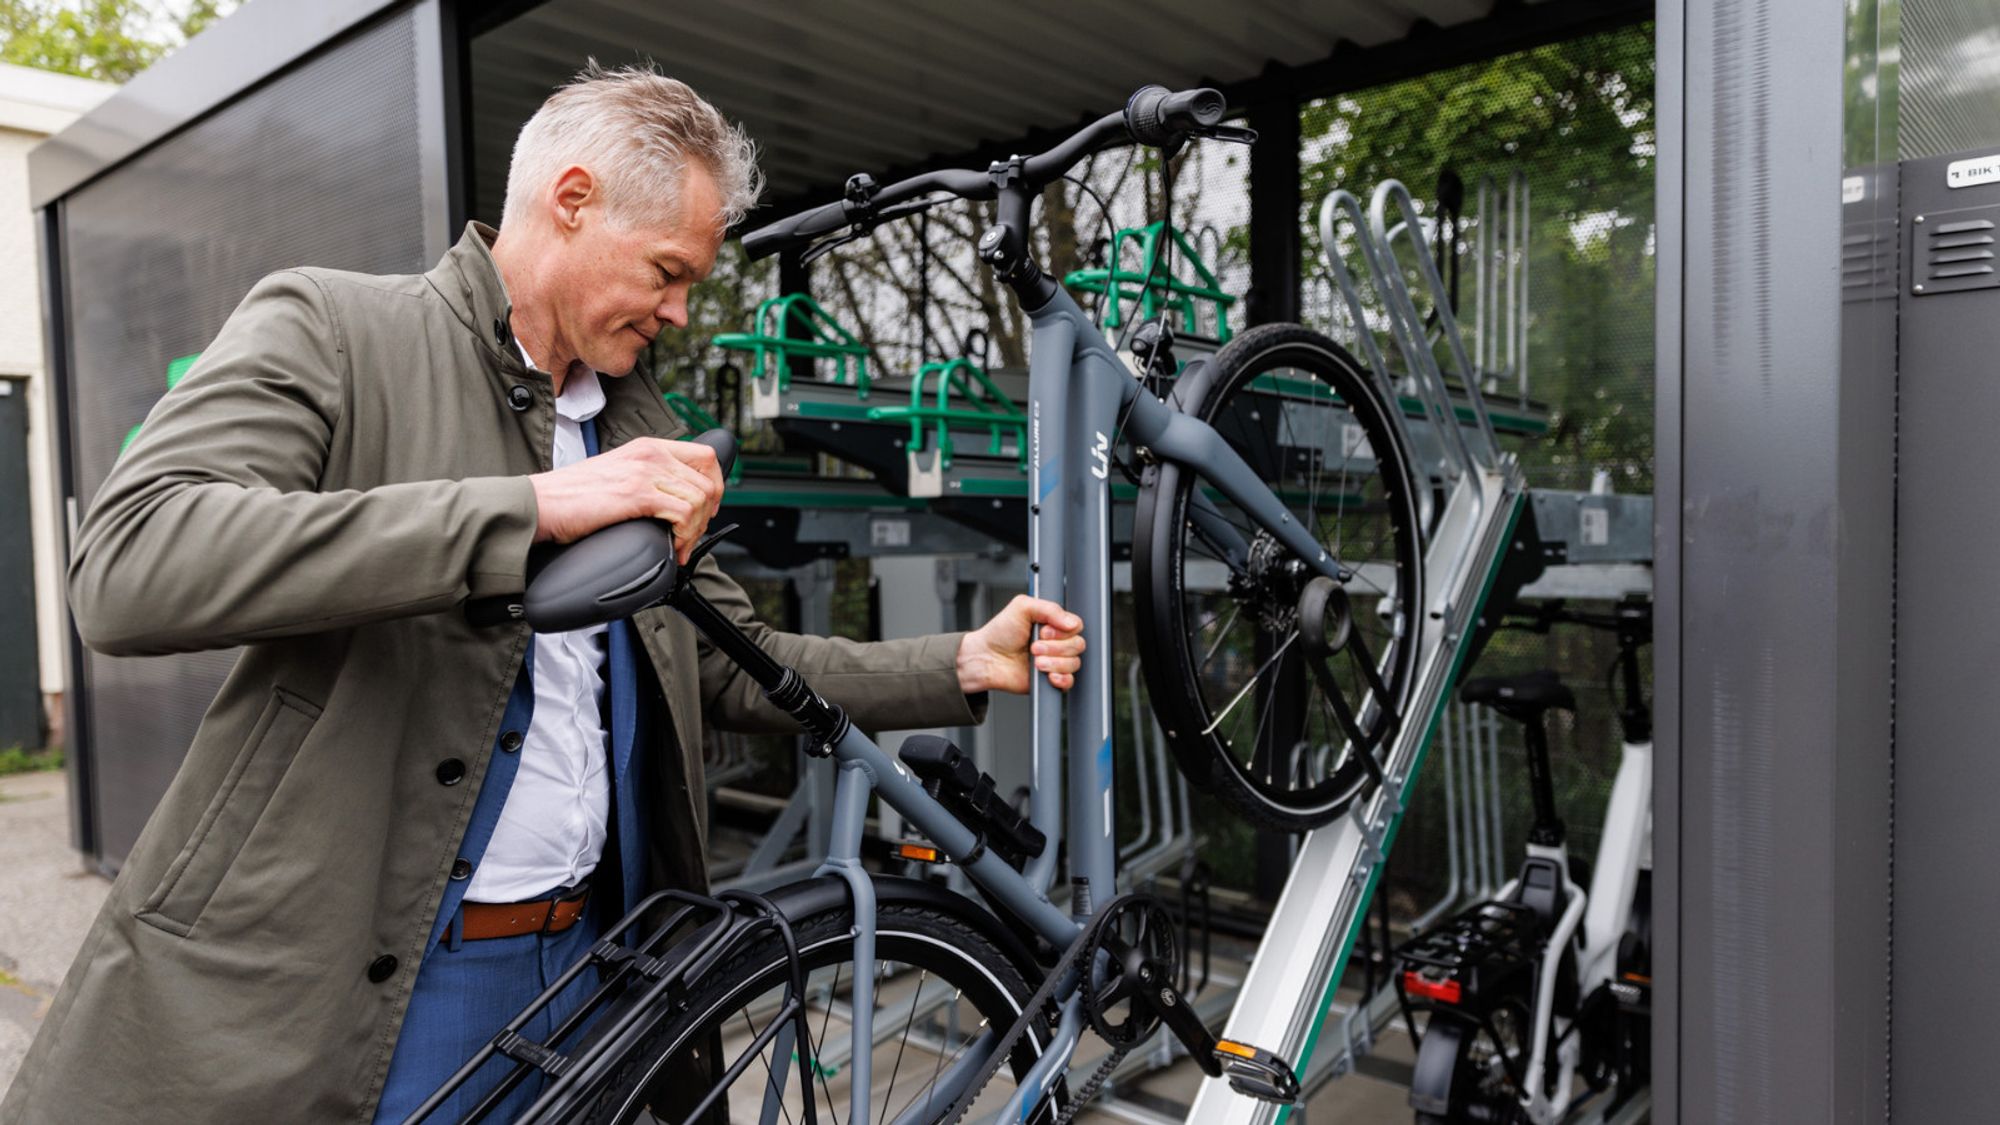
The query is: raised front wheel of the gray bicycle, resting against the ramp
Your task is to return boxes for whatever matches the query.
[1132,324,1424,831]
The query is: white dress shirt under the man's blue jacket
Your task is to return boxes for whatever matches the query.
[466,348,612,903]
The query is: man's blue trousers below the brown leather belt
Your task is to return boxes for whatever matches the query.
[374,909,598,1125]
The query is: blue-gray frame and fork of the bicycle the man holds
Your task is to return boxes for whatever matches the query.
[766,278,1342,1121]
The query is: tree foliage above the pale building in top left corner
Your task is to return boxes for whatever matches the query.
[0,0,238,82]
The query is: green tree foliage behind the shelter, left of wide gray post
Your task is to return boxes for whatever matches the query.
[1300,24,1656,492]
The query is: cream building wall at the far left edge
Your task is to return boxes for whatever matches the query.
[0,64,116,741]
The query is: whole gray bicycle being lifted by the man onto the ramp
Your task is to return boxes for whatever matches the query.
[418,86,1424,1125]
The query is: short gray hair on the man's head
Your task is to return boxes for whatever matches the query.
[500,58,764,228]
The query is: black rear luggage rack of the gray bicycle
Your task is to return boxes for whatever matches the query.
[404,891,818,1125]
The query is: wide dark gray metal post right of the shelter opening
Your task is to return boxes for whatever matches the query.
[1654,0,1898,1121]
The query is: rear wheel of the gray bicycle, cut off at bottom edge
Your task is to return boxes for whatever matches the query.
[584,895,1060,1125]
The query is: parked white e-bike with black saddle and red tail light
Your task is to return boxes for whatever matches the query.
[1396,601,1652,1125]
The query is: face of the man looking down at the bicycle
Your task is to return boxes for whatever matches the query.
[554,164,724,374]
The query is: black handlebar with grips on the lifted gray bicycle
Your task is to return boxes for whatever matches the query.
[742,86,1228,260]
